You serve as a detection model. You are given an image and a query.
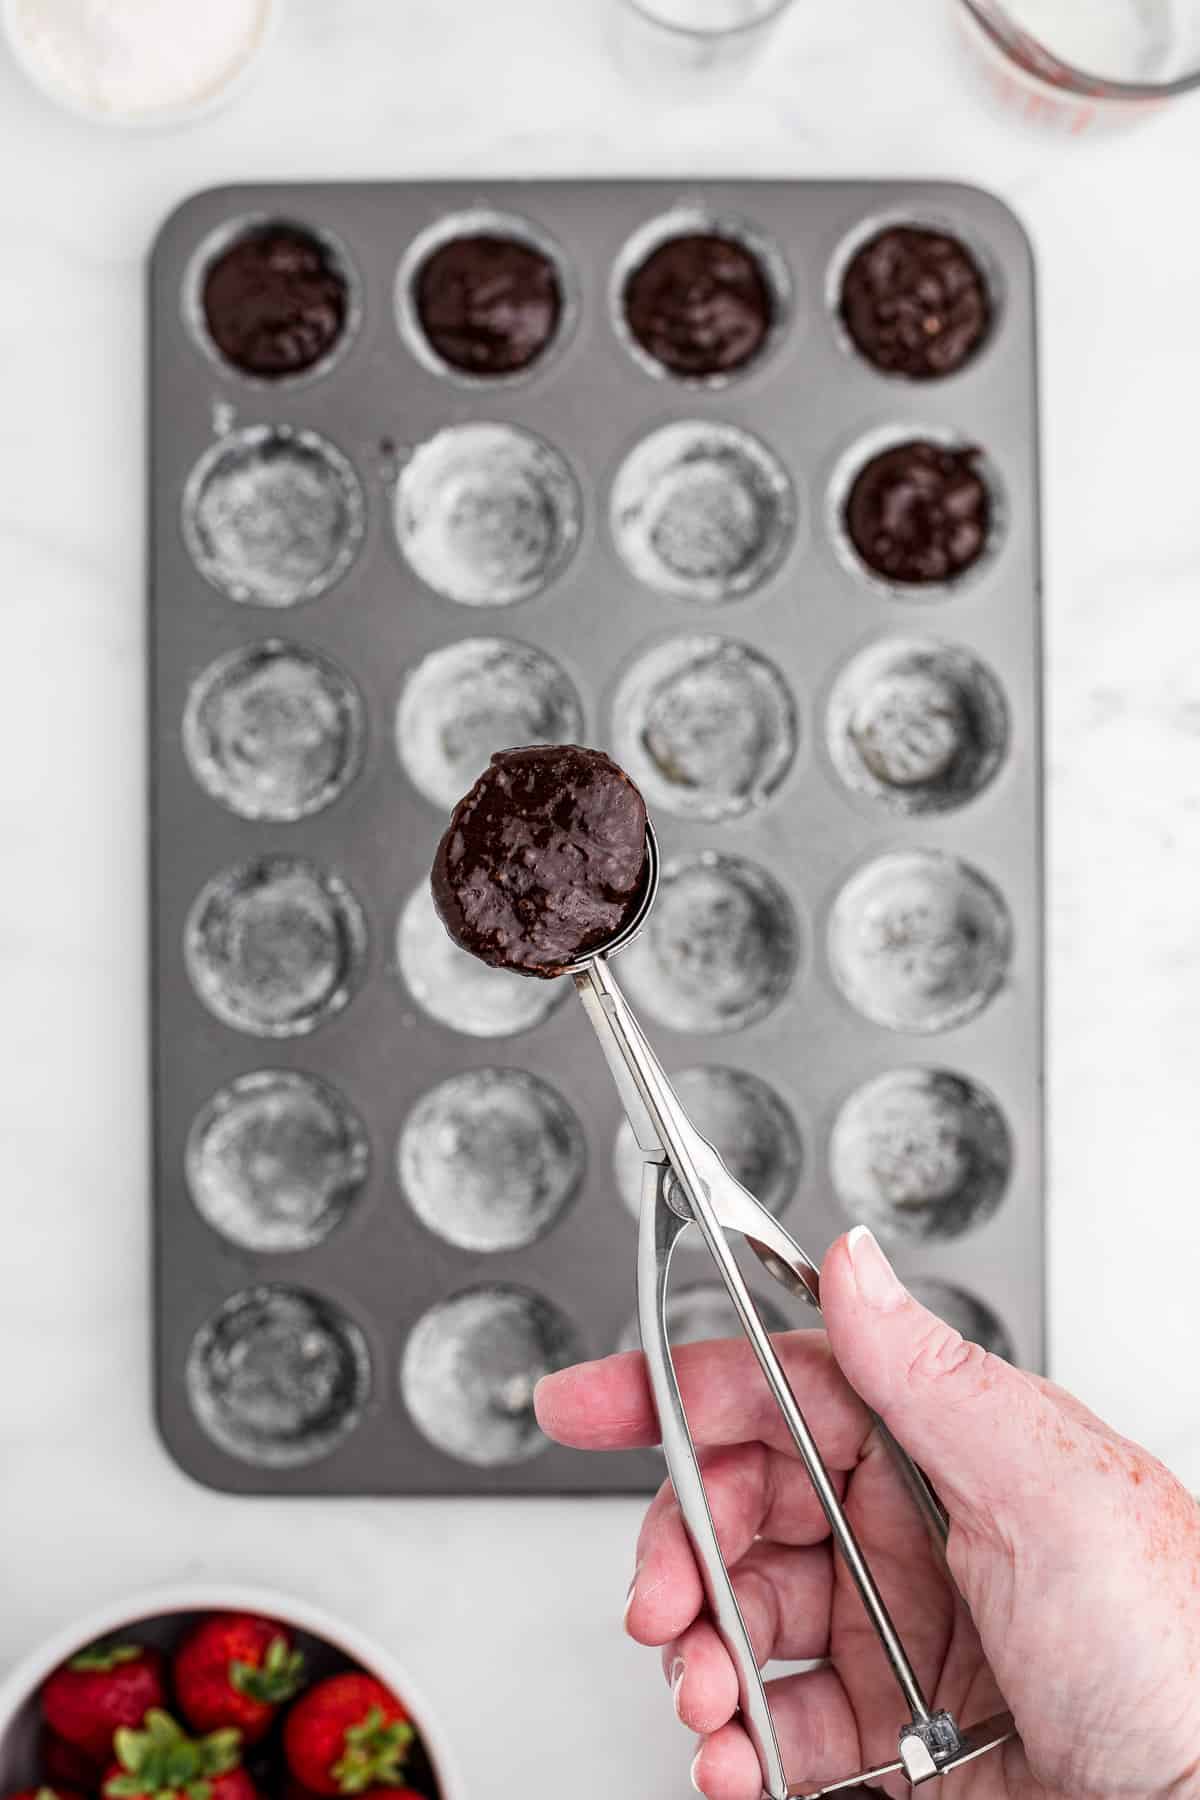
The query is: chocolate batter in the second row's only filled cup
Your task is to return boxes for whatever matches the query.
[844,439,991,585]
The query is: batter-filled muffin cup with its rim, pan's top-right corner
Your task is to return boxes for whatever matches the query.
[826,216,1002,382]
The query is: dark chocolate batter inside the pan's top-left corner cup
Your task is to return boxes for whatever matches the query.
[203,225,347,376]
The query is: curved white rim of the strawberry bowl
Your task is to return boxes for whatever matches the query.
[0,1580,466,1800]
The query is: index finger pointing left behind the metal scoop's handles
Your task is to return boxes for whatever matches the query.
[534,1330,871,1469]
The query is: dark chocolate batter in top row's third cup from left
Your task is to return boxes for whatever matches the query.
[624,232,774,376]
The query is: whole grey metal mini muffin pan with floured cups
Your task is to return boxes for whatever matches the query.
[149,182,1043,1494]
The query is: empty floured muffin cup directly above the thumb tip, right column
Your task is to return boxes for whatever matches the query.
[829,1069,1013,1244]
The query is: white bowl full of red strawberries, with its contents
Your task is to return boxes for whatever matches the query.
[0,1588,461,1800]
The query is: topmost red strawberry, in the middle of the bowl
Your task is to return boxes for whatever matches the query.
[175,1613,304,1744]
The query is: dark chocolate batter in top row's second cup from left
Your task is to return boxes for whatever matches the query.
[416,236,563,374]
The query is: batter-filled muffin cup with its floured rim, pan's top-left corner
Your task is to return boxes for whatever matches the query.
[184,216,362,385]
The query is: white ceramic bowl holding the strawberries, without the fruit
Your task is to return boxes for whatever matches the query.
[0,1584,464,1800]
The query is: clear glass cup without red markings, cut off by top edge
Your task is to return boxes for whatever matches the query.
[613,0,792,97]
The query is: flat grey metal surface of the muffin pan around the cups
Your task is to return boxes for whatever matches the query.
[148,180,1045,1494]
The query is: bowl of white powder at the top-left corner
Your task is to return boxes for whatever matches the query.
[11,0,270,119]
